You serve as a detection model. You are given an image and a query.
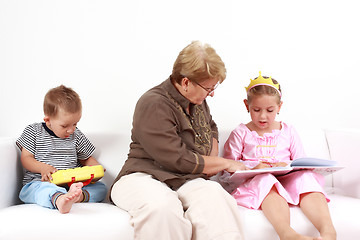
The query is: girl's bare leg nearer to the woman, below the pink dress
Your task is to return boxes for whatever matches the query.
[261,187,317,240]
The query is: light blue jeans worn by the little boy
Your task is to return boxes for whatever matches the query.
[19,181,107,209]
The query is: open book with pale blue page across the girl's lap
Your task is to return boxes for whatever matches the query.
[228,158,344,182]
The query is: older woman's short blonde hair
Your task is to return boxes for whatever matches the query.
[171,41,226,83]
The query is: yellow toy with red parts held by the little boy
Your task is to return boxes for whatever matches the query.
[51,165,104,186]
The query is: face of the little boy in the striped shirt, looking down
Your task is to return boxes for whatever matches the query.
[44,108,81,139]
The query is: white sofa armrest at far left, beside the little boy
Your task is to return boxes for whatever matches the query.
[0,138,22,209]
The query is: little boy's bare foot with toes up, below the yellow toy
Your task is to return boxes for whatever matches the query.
[55,182,83,213]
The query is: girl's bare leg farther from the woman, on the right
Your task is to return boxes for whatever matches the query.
[300,192,336,240]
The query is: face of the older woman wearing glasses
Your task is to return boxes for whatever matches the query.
[185,79,218,105]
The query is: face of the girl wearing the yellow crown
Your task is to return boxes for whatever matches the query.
[244,94,282,132]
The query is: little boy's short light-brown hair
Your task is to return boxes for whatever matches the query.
[44,85,82,116]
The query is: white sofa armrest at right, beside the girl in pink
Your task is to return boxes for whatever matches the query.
[325,129,360,198]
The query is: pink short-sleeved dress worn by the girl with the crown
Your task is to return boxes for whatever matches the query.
[224,122,329,209]
